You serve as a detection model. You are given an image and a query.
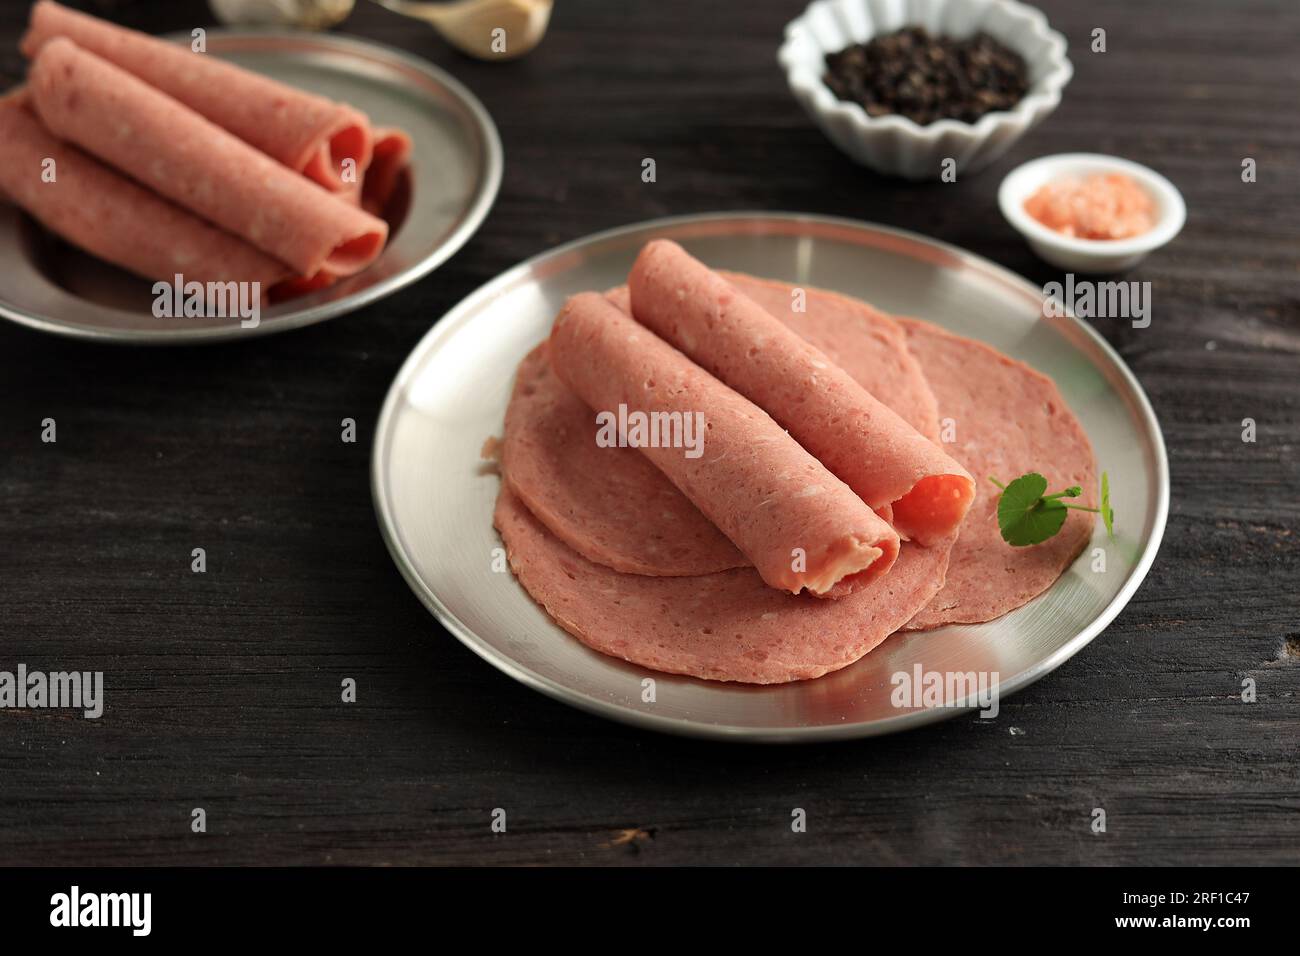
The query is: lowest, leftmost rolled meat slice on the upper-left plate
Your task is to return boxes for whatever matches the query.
[0,95,289,291]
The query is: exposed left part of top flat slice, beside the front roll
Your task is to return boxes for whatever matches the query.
[501,342,749,575]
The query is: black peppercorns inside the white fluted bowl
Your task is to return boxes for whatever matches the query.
[826,26,1030,126]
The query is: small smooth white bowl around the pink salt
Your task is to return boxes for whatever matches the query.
[997,152,1187,272]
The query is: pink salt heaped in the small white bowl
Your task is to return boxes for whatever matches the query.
[1024,173,1156,239]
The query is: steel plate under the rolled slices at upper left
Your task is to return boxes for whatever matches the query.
[0,30,502,343]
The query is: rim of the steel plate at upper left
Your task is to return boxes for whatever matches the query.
[0,29,506,346]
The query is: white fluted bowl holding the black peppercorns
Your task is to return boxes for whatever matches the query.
[776,0,1074,179]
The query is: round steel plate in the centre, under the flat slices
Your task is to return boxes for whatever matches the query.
[372,213,1169,741]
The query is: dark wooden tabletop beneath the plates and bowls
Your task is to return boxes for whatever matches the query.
[0,0,1300,868]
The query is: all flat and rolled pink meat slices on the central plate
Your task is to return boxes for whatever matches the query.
[495,241,1096,683]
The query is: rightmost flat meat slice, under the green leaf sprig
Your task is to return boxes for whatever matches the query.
[898,319,1097,630]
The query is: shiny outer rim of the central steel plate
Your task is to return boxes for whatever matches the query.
[371,211,1170,744]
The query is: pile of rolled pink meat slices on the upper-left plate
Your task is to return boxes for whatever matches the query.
[0,0,411,299]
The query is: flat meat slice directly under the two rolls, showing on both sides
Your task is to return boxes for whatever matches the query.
[501,283,939,576]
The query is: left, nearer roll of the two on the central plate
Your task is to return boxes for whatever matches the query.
[550,293,898,597]
